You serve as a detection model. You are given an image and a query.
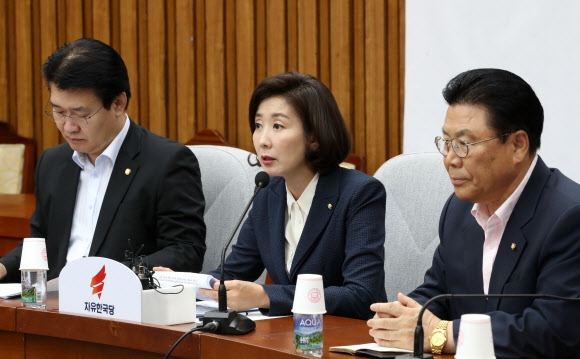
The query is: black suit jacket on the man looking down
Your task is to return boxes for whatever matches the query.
[0,121,205,282]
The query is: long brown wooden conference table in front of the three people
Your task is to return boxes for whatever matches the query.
[0,292,453,359]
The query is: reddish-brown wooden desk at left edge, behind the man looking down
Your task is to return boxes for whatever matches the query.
[0,193,35,257]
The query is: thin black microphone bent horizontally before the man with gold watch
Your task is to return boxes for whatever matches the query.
[395,294,580,359]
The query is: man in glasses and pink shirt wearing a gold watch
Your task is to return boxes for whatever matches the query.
[368,69,580,358]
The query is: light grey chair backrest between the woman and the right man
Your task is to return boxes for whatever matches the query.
[374,152,453,300]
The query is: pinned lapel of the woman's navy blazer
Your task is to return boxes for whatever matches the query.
[290,167,341,280]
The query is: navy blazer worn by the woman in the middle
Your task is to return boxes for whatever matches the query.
[211,166,387,319]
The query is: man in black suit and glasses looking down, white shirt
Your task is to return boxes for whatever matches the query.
[0,39,205,282]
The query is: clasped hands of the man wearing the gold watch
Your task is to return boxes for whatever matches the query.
[367,293,439,351]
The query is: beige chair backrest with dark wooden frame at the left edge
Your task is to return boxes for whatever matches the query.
[0,122,36,193]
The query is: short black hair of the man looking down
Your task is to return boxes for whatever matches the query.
[42,38,131,110]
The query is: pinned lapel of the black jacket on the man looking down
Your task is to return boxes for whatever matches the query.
[89,120,142,256]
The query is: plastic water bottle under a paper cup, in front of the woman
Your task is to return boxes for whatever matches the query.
[294,313,323,358]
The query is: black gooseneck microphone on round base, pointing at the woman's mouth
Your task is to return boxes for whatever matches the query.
[203,171,270,335]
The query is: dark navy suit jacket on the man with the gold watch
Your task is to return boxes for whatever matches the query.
[411,158,580,358]
